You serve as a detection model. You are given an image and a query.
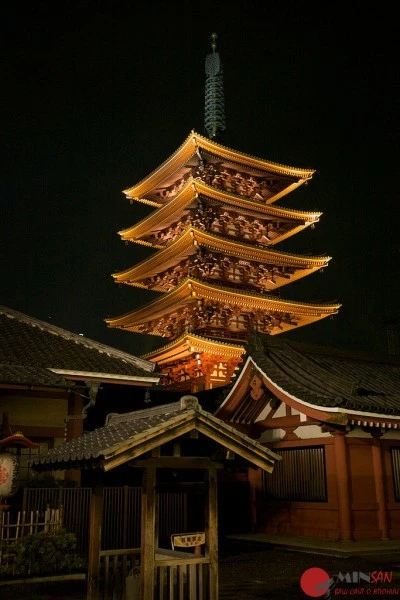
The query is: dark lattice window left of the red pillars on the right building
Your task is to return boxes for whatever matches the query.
[263,446,328,502]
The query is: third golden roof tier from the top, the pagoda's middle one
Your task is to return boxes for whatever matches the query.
[113,227,331,292]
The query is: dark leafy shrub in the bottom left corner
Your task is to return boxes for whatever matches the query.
[0,529,85,578]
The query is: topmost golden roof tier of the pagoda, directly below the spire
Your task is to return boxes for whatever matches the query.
[124,130,315,206]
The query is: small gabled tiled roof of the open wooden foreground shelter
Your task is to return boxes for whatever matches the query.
[31,396,279,471]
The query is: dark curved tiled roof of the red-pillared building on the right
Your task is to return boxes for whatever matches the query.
[248,336,400,415]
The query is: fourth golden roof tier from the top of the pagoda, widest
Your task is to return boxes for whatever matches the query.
[106,277,340,342]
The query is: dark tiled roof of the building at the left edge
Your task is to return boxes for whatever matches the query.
[0,306,157,387]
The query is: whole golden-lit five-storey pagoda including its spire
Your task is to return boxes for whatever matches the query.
[106,34,340,393]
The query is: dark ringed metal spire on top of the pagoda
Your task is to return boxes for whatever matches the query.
[204,33,225,139]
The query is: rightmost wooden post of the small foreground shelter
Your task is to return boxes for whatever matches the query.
[205,466,218,600]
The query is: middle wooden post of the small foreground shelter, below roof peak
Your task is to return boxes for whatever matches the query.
[140,465,156,600]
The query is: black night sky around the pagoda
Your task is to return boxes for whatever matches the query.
[0,1,400,355]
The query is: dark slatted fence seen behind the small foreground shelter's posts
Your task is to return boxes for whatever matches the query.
[22,486,188,556]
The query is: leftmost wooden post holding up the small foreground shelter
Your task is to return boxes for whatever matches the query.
[87,481,103,600]
